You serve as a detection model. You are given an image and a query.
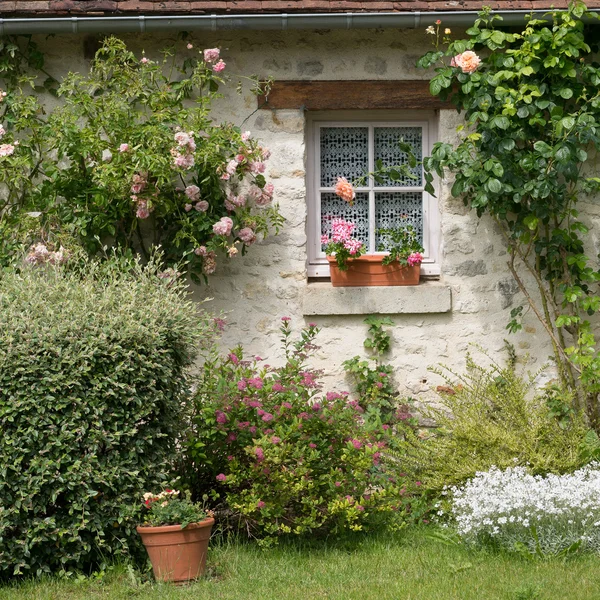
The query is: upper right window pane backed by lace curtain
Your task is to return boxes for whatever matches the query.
[374,127,423,187]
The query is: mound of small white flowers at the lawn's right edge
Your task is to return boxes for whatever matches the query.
[446,464,600,554]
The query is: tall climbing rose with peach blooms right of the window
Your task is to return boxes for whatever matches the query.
[419,2,600,429]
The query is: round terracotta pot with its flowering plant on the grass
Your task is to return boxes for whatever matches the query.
[137,489,215,582]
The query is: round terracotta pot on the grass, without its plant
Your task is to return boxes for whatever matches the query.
[137,518,215,582]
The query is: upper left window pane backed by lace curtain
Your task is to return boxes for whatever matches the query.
[321,127,369,187]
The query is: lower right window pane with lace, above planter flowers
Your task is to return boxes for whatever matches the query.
[375,192,423,248]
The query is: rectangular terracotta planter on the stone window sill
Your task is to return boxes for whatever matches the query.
[327,255,421,287]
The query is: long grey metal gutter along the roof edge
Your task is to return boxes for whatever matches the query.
[0,9,598,37]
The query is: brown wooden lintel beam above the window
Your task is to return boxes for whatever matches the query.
[258,80,453,110]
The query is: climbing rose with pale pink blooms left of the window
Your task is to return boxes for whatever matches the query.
[0,37,282,279]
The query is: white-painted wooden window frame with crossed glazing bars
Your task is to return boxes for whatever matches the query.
[306,110,441,278]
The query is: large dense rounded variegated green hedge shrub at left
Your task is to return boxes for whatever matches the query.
[0,262,212,577]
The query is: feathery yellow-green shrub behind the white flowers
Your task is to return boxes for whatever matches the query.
[403,346,585,491]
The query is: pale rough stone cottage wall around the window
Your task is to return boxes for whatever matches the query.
[34,29,550,404]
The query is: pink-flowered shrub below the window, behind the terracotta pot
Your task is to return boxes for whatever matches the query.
[188,317,412,539]
